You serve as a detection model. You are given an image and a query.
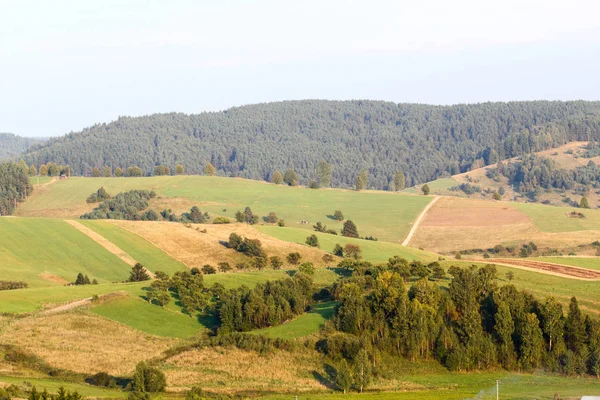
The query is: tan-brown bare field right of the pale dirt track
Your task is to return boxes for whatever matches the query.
[411,197,600,252]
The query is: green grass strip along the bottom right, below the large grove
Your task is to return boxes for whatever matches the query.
[266,372,600,400]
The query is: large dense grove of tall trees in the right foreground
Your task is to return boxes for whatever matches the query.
[328,260,600,376]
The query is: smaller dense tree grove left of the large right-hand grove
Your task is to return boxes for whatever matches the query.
[217,272,313,334]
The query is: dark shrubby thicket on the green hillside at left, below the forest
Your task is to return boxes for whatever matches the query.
[80,190,158,220]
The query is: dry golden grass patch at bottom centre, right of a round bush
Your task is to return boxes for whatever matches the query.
[165,347,326,393]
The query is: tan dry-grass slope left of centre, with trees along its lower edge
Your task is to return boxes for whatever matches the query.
[111,221,325,268]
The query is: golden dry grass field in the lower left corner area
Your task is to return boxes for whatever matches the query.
[0,312,175,375]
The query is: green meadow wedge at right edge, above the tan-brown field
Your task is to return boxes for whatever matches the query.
[510,202,600,233]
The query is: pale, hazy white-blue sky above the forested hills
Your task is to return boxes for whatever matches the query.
[0,0,600,137]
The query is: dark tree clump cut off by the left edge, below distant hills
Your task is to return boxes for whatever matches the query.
[0,163,33,216]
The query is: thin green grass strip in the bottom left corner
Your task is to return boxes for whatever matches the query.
[0,376,127,399]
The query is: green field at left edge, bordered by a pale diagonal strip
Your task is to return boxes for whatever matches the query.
[0,218,130,287]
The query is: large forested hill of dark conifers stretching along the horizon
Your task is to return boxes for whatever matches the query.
[21,100,600,189]
